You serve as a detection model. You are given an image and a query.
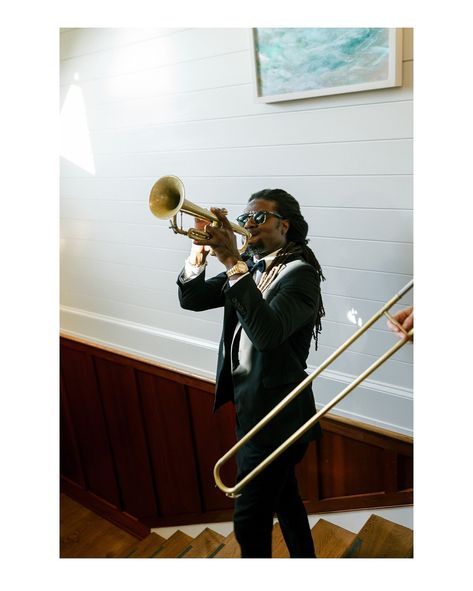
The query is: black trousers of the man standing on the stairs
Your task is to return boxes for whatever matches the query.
[233,442,315,558]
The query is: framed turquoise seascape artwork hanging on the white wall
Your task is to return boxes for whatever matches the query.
[251,28,402,103]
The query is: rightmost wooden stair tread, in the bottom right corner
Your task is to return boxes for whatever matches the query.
[347,515,414,558]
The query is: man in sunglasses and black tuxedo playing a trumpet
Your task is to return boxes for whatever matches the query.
[178,189,324,558]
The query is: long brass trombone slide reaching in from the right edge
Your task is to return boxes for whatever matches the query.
[214,281,414,498]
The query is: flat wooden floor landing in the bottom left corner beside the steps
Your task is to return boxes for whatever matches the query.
[60,494,138,558]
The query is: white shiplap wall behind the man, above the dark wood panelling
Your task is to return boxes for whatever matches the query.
[61,29,413,434]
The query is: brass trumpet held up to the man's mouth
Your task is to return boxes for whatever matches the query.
[149,175,251,253]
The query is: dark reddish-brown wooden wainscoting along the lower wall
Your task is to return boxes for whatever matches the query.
[60,337,413,536]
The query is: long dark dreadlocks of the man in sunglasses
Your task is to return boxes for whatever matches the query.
[248,189,325,350]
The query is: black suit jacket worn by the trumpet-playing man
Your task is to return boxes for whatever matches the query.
[178,260,321,447]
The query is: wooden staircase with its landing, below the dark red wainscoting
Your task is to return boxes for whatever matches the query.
[61,499,413,558]
